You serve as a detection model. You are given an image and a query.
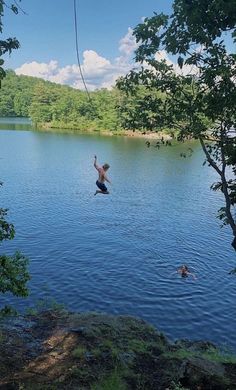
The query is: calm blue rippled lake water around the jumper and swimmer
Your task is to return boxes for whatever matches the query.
[0,120,236,349]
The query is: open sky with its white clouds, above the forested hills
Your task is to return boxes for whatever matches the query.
[3,0,236,90]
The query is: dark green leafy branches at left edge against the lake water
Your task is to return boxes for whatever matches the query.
[0,183,30,315]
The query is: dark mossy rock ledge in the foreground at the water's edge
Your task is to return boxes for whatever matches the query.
[0,310,236,390]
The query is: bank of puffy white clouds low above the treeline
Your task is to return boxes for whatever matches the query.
[15,27,199,91]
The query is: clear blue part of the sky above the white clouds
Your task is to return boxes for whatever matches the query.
[4,0,172,67]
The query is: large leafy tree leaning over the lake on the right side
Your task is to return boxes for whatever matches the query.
[118,0,236,249]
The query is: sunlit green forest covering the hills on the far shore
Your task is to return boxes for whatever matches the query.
[0,70,171,132]
